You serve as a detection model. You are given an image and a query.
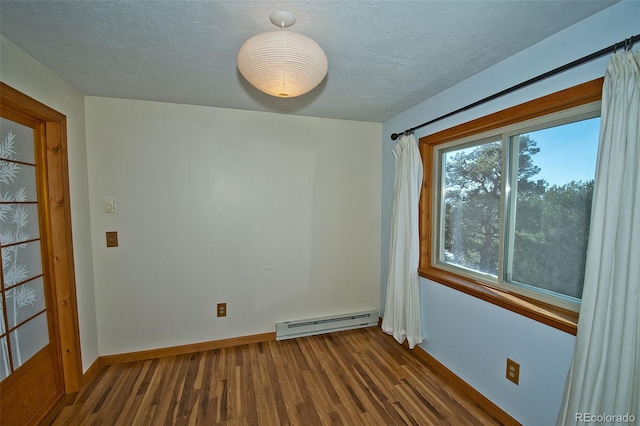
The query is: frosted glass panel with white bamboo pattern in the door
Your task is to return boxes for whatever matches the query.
[0,118,49,380]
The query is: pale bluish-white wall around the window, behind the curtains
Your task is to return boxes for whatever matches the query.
[381,1,640,426]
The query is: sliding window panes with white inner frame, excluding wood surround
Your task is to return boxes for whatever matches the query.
[434,110,600,308]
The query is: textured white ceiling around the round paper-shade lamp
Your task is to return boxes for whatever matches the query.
[0,0,615,122]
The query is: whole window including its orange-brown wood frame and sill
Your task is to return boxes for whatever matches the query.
[420,79,602,333]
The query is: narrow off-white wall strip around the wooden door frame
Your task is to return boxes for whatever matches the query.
[0,36,98,370]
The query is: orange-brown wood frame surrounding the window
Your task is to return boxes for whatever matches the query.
[418,78,604,335]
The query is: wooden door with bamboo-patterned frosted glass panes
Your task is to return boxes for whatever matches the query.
[0,109,64,424]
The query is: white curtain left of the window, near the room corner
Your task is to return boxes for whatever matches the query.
[382,135,422,349]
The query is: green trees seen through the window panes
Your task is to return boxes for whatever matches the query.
[444,135,593,298]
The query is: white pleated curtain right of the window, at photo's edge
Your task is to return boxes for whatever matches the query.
[557,52,640,425]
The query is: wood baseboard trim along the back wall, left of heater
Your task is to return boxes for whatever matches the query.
[99,332,276,371]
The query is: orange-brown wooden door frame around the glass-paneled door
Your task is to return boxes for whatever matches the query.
[0,82,83,394]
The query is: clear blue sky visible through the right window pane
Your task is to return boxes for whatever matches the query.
[527,117,600,186]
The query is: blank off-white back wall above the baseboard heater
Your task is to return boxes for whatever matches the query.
[85,97,382,355]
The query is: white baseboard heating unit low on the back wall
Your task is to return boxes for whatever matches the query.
[276,311,379,340]
